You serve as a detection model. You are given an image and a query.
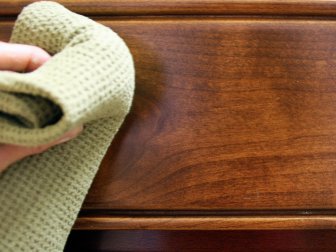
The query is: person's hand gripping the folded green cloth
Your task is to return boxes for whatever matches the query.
[0,41,83,173]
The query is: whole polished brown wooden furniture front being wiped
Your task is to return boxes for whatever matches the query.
[0,0,336,251]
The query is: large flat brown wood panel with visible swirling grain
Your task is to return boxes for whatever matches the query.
[0,18,336,210]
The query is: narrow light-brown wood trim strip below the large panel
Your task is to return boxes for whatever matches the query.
[74,216,336,230]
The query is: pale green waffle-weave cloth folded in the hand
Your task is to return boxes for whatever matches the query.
[0,2,135,252]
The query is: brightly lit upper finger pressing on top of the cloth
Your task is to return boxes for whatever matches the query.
[0,41,50,72]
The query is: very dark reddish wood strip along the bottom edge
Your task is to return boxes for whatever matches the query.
[65,230,336,252]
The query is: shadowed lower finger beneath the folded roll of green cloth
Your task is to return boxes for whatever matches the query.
[0,126,83,173]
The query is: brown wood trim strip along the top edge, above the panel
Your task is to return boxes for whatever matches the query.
[0,0,336,16]
